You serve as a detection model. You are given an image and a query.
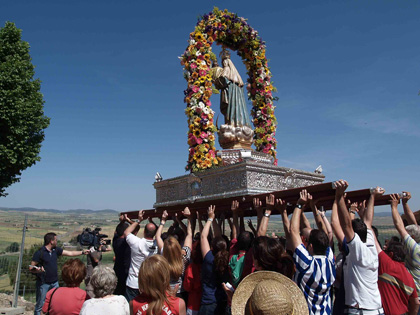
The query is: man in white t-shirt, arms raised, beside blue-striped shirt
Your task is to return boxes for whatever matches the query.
[335,180,385,314]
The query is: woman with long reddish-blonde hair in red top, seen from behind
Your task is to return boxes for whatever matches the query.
[130,255,186,315]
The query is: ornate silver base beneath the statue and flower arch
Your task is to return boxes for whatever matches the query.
[153,150,325,208]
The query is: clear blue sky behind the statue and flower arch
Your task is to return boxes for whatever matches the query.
[0,0,420,211]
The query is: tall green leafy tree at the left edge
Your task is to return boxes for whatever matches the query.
[0,22,50,197]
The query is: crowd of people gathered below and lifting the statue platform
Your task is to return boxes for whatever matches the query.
[32,180,420,315]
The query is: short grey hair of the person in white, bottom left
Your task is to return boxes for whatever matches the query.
[90,265,117,298]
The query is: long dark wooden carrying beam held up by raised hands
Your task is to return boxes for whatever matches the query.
[123,182,391,219]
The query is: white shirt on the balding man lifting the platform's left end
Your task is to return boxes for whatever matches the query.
[126,233,158,289]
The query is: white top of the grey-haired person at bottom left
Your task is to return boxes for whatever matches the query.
[80,295,130,315]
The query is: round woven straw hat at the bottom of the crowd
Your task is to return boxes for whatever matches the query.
[232,271,309,315]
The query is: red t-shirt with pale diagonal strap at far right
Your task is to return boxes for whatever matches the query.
[378,251,417,315]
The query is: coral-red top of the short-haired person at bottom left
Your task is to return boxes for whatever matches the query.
[42,287,89,315]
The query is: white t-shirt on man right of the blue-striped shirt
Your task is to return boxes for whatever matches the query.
[343,229,382,310]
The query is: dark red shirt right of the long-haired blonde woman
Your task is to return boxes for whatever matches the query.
[184,262,202,311]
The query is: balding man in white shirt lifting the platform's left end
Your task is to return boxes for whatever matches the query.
[124,210,158,302]
